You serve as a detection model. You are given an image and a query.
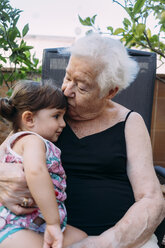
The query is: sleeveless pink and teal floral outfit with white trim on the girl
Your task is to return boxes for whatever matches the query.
[0,131,67,243]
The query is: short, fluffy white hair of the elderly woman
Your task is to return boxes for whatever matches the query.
[71,34,139,95]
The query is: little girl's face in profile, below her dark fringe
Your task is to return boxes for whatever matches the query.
[31,108,66,142]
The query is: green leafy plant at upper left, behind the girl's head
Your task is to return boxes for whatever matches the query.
[0,0,41,95]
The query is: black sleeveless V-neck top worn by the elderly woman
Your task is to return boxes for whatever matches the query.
[56,112,135,235]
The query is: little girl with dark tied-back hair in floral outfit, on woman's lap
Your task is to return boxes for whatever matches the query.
[0,82,86,248]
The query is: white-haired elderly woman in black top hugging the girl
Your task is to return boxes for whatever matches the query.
[0,35,165,248]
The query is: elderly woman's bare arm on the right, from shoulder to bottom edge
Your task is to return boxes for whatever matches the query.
[67,113,165,248]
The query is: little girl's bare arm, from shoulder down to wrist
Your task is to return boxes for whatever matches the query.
[22,135,60,225]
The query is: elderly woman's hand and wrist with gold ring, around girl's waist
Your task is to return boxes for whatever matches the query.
[0,163,35,215]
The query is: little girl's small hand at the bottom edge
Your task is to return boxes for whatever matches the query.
[43,224,63,248]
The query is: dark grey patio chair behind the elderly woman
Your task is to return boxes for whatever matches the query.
[42,48,165,248]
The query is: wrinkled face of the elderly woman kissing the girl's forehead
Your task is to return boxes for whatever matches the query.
[62,56,105,120]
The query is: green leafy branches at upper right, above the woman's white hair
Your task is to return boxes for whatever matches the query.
[79,0,165,68]
